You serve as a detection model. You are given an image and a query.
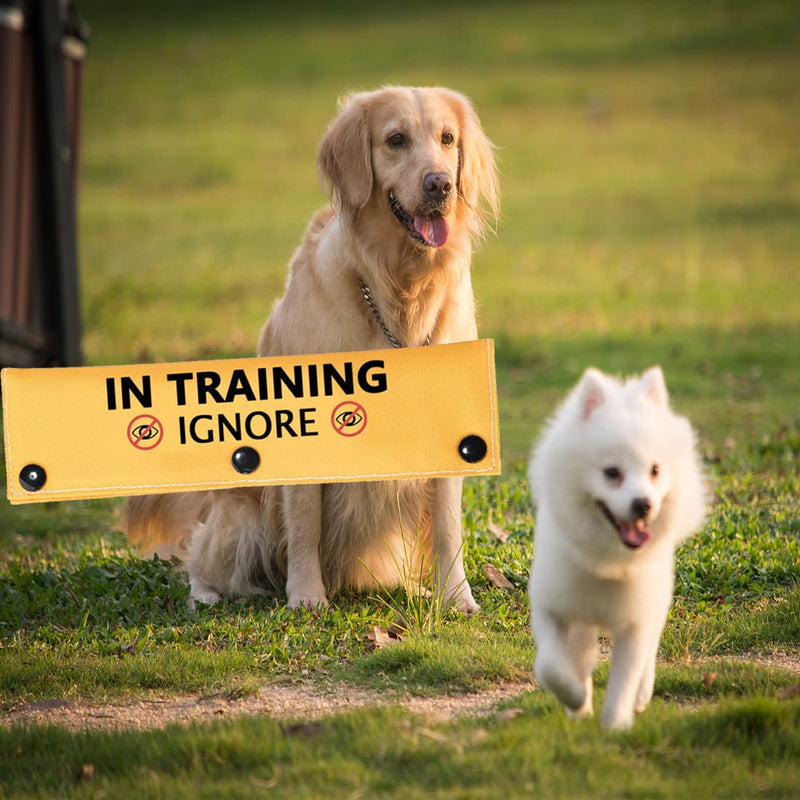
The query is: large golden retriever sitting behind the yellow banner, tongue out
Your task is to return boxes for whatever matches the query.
[126,87,499,612]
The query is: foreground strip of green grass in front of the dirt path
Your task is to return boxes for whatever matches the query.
[0,693,800,798]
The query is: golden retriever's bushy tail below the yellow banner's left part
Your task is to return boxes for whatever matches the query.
[122,492,211,558]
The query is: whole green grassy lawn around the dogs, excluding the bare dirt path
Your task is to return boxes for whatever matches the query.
[0,0,800,798]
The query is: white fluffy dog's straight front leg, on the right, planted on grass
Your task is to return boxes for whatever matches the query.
[602,627,655,728]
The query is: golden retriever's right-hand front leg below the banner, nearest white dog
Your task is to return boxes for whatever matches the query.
[431,478,480,614]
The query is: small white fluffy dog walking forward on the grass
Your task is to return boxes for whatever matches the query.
[528,367,705,728]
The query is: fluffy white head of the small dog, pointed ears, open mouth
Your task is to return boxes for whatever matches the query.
[531,367,705,552]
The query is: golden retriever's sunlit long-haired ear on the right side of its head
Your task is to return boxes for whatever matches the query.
[450,92,500,233]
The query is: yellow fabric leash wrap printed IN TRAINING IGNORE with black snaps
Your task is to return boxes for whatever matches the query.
[2,339,500,504]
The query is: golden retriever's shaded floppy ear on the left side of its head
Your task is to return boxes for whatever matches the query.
[317,93,372,212]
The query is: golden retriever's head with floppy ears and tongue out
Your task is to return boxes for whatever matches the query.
[318,87,499,249]
